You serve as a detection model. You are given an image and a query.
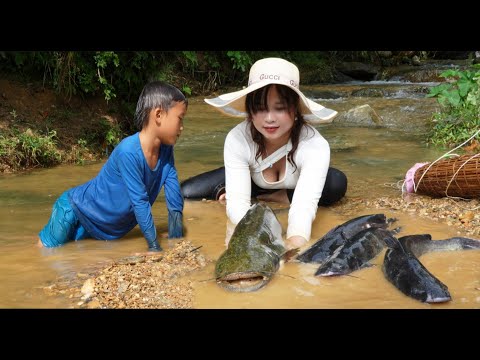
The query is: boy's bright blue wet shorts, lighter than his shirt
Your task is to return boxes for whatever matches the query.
[38,190,90,247]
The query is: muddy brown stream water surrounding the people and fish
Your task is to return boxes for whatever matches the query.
[0,88,480,309]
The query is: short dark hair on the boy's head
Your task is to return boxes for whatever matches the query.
[134,81,188,130]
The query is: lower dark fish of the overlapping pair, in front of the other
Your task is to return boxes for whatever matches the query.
[315,228,393,276]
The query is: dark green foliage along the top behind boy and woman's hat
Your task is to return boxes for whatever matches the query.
[0,51,338,102]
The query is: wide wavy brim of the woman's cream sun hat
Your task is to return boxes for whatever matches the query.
[204,80,338,124]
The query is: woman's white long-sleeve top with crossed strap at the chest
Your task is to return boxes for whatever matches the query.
[224,120,330,240]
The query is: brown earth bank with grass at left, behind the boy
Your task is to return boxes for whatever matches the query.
[0,79,114,173]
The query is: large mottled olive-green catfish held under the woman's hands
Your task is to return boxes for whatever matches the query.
[215,203,289,292]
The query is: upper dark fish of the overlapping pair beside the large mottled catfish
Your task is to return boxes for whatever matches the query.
[296,214,398,264]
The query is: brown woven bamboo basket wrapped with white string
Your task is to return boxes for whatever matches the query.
[414,154,480,199]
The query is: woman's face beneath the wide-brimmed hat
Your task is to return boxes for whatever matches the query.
[252,86,295,143]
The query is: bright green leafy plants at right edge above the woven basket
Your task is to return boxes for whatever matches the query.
[427,64,480,147]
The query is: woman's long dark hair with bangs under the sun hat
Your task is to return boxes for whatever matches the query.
[245,84,308,169]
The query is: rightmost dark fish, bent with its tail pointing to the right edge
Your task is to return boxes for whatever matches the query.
[383,234,480,303]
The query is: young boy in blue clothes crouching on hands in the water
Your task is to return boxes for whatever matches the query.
[39,81,188,251]
